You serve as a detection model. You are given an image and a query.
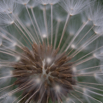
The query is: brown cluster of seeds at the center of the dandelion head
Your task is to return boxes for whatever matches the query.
[13,43,75,102]
